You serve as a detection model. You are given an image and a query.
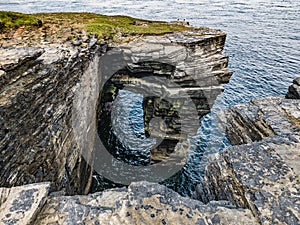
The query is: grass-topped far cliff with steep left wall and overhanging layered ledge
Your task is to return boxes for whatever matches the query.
[0,12,231,194]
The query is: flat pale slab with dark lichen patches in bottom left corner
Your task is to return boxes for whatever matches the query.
[0,183,50,225]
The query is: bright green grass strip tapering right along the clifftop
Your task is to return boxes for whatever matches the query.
[35,13,191,38]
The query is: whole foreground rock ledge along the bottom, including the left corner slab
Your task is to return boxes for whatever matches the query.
[0,182,258,225]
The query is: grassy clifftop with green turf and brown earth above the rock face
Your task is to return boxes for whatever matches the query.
[0,11,192,42]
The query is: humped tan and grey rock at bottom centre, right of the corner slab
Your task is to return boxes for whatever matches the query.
[35,182,258,225]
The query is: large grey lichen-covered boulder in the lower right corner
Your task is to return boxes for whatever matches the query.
[195,135,300,224]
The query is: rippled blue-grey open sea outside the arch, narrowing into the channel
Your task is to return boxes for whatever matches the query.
[0,0,300,195]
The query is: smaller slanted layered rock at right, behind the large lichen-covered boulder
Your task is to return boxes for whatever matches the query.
[226,97,300,145]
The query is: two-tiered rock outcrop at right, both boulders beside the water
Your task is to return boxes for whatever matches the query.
[194,81,300,225]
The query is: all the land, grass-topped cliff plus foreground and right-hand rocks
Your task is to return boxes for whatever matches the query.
[0,12,300,225]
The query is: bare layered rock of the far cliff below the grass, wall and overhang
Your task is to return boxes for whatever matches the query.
[0,26,231,194]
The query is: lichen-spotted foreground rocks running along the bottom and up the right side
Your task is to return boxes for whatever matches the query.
[0,79,300,225]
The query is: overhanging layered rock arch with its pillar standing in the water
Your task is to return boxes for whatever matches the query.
[99,30,232,164]
